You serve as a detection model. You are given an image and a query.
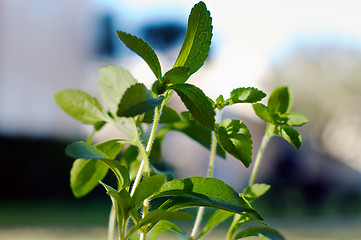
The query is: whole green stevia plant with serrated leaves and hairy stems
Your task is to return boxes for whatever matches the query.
[54,2,307,240]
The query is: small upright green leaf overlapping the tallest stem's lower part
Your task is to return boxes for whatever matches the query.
[130,174,166,209]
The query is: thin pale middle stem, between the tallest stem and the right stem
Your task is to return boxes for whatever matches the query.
[189,110,221,240]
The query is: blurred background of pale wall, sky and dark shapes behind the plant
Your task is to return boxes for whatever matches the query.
[0,0,361,240]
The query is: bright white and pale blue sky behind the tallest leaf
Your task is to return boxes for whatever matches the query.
[93,0,361,96]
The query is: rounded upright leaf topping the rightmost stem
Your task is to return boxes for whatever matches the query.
[267,87,292,114]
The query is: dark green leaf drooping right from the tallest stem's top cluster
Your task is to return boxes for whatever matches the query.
[169,83,216,130]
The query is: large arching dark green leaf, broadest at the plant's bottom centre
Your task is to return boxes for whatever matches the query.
[152,177,262,219]
